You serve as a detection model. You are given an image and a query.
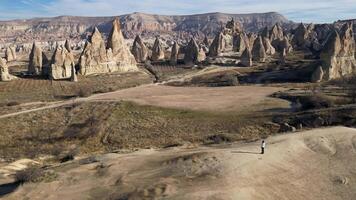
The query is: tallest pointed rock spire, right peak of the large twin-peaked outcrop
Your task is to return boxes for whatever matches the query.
[107,18,138,72]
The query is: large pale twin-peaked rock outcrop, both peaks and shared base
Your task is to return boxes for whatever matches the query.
[79,19,138,75]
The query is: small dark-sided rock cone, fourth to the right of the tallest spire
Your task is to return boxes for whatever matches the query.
[184,38,205,64]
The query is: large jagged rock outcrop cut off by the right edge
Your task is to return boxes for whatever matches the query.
[320,24,356,80]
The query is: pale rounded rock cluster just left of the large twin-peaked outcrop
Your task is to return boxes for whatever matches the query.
[49,46,75,80]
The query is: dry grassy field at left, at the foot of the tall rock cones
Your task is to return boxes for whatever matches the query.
[0,72,152,104]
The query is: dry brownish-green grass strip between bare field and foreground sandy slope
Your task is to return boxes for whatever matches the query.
[0,102,276,159]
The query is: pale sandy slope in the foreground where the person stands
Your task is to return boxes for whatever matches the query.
[4,127,356,200]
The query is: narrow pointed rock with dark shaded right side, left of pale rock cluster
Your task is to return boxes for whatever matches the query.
[28,42,48,76]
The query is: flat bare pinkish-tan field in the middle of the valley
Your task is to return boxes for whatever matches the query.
[90,85,289,112]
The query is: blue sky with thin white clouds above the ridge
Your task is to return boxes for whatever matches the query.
[0,0,356,23]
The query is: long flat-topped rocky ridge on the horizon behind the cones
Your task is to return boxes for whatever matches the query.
[0,12,291,42]
